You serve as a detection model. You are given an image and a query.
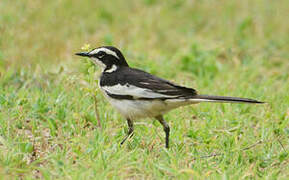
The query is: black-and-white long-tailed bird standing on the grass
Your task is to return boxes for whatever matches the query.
[75,46,264,148]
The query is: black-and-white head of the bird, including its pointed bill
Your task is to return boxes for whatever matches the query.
[75,46,128,72]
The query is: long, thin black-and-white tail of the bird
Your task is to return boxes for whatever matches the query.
[191,95,264,104]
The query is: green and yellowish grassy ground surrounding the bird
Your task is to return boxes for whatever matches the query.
[0,0,289,179]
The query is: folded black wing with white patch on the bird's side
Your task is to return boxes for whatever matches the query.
[102,69,197,100]
